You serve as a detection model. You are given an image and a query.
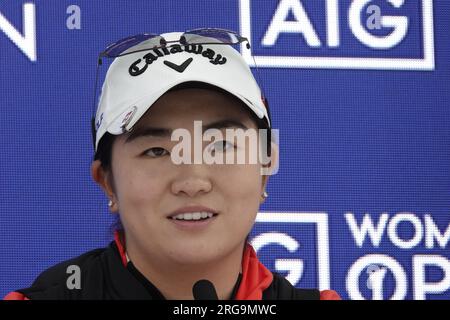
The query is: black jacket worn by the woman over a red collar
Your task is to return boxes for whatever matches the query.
[7,242,320,300]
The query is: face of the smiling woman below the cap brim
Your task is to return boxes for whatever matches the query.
[94,88,265,263]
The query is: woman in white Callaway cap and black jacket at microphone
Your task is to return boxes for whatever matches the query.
[6,29,339,300]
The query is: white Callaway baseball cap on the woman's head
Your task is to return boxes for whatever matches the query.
[95,32,270,150]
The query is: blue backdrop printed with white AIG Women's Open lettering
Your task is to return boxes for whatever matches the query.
[0,0,450,299]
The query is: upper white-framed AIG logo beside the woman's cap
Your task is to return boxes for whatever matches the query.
[240,0,435,70]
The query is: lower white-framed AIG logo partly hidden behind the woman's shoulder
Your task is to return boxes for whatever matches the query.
[250,212,330,290]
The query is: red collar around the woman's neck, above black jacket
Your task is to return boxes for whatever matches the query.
[114,231,273,300]
